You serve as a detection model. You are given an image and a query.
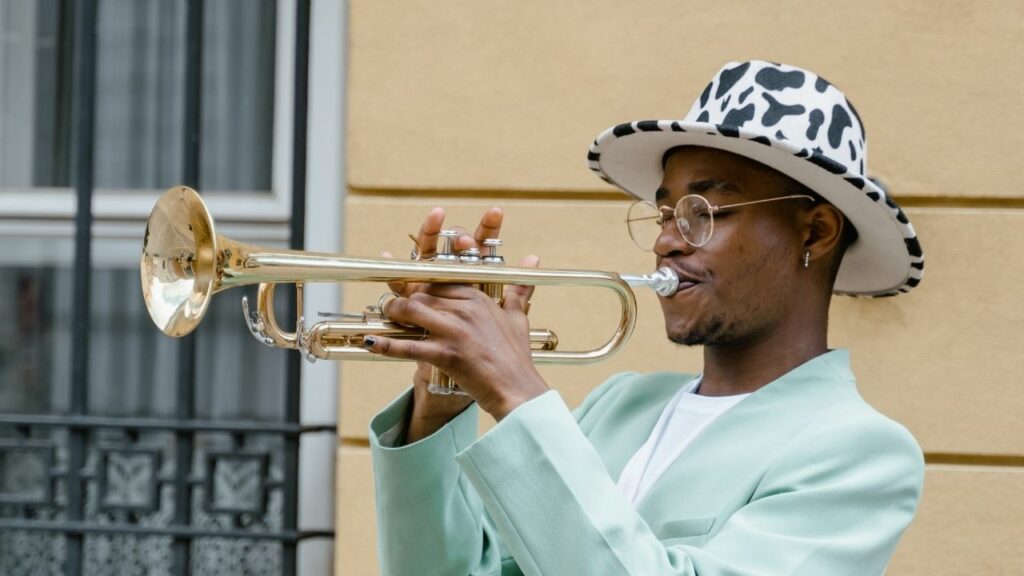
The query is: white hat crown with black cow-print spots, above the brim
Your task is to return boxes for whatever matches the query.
[684,60,867,177]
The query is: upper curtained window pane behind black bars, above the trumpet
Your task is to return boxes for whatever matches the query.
[0,0,276,191]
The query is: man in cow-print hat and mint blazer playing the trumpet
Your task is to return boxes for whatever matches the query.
[366,61,924,576]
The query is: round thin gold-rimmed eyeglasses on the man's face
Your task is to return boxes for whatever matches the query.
[626,194,814,252]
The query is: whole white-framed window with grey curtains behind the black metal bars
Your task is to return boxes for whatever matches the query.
[0,0,344,574]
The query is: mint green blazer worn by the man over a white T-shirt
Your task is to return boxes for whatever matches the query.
[370,351,924,576]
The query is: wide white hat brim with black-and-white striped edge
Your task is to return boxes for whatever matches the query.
[588,120,925,296]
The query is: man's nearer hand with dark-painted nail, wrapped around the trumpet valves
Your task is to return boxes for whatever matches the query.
[364,256,548,420]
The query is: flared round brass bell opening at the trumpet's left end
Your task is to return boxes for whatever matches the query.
[139,187,218,336]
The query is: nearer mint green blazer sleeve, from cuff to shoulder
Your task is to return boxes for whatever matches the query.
[456,392,923,576]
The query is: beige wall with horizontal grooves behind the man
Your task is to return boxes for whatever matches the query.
[337,0,1024,576]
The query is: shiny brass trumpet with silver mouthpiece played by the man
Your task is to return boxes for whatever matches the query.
[139,187,679,393]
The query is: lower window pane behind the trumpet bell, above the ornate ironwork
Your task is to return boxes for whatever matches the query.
[0,238,288,421]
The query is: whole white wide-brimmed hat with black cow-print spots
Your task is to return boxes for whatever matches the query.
[587,60,925,296]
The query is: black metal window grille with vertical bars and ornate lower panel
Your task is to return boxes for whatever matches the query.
[0,0,334,575]
